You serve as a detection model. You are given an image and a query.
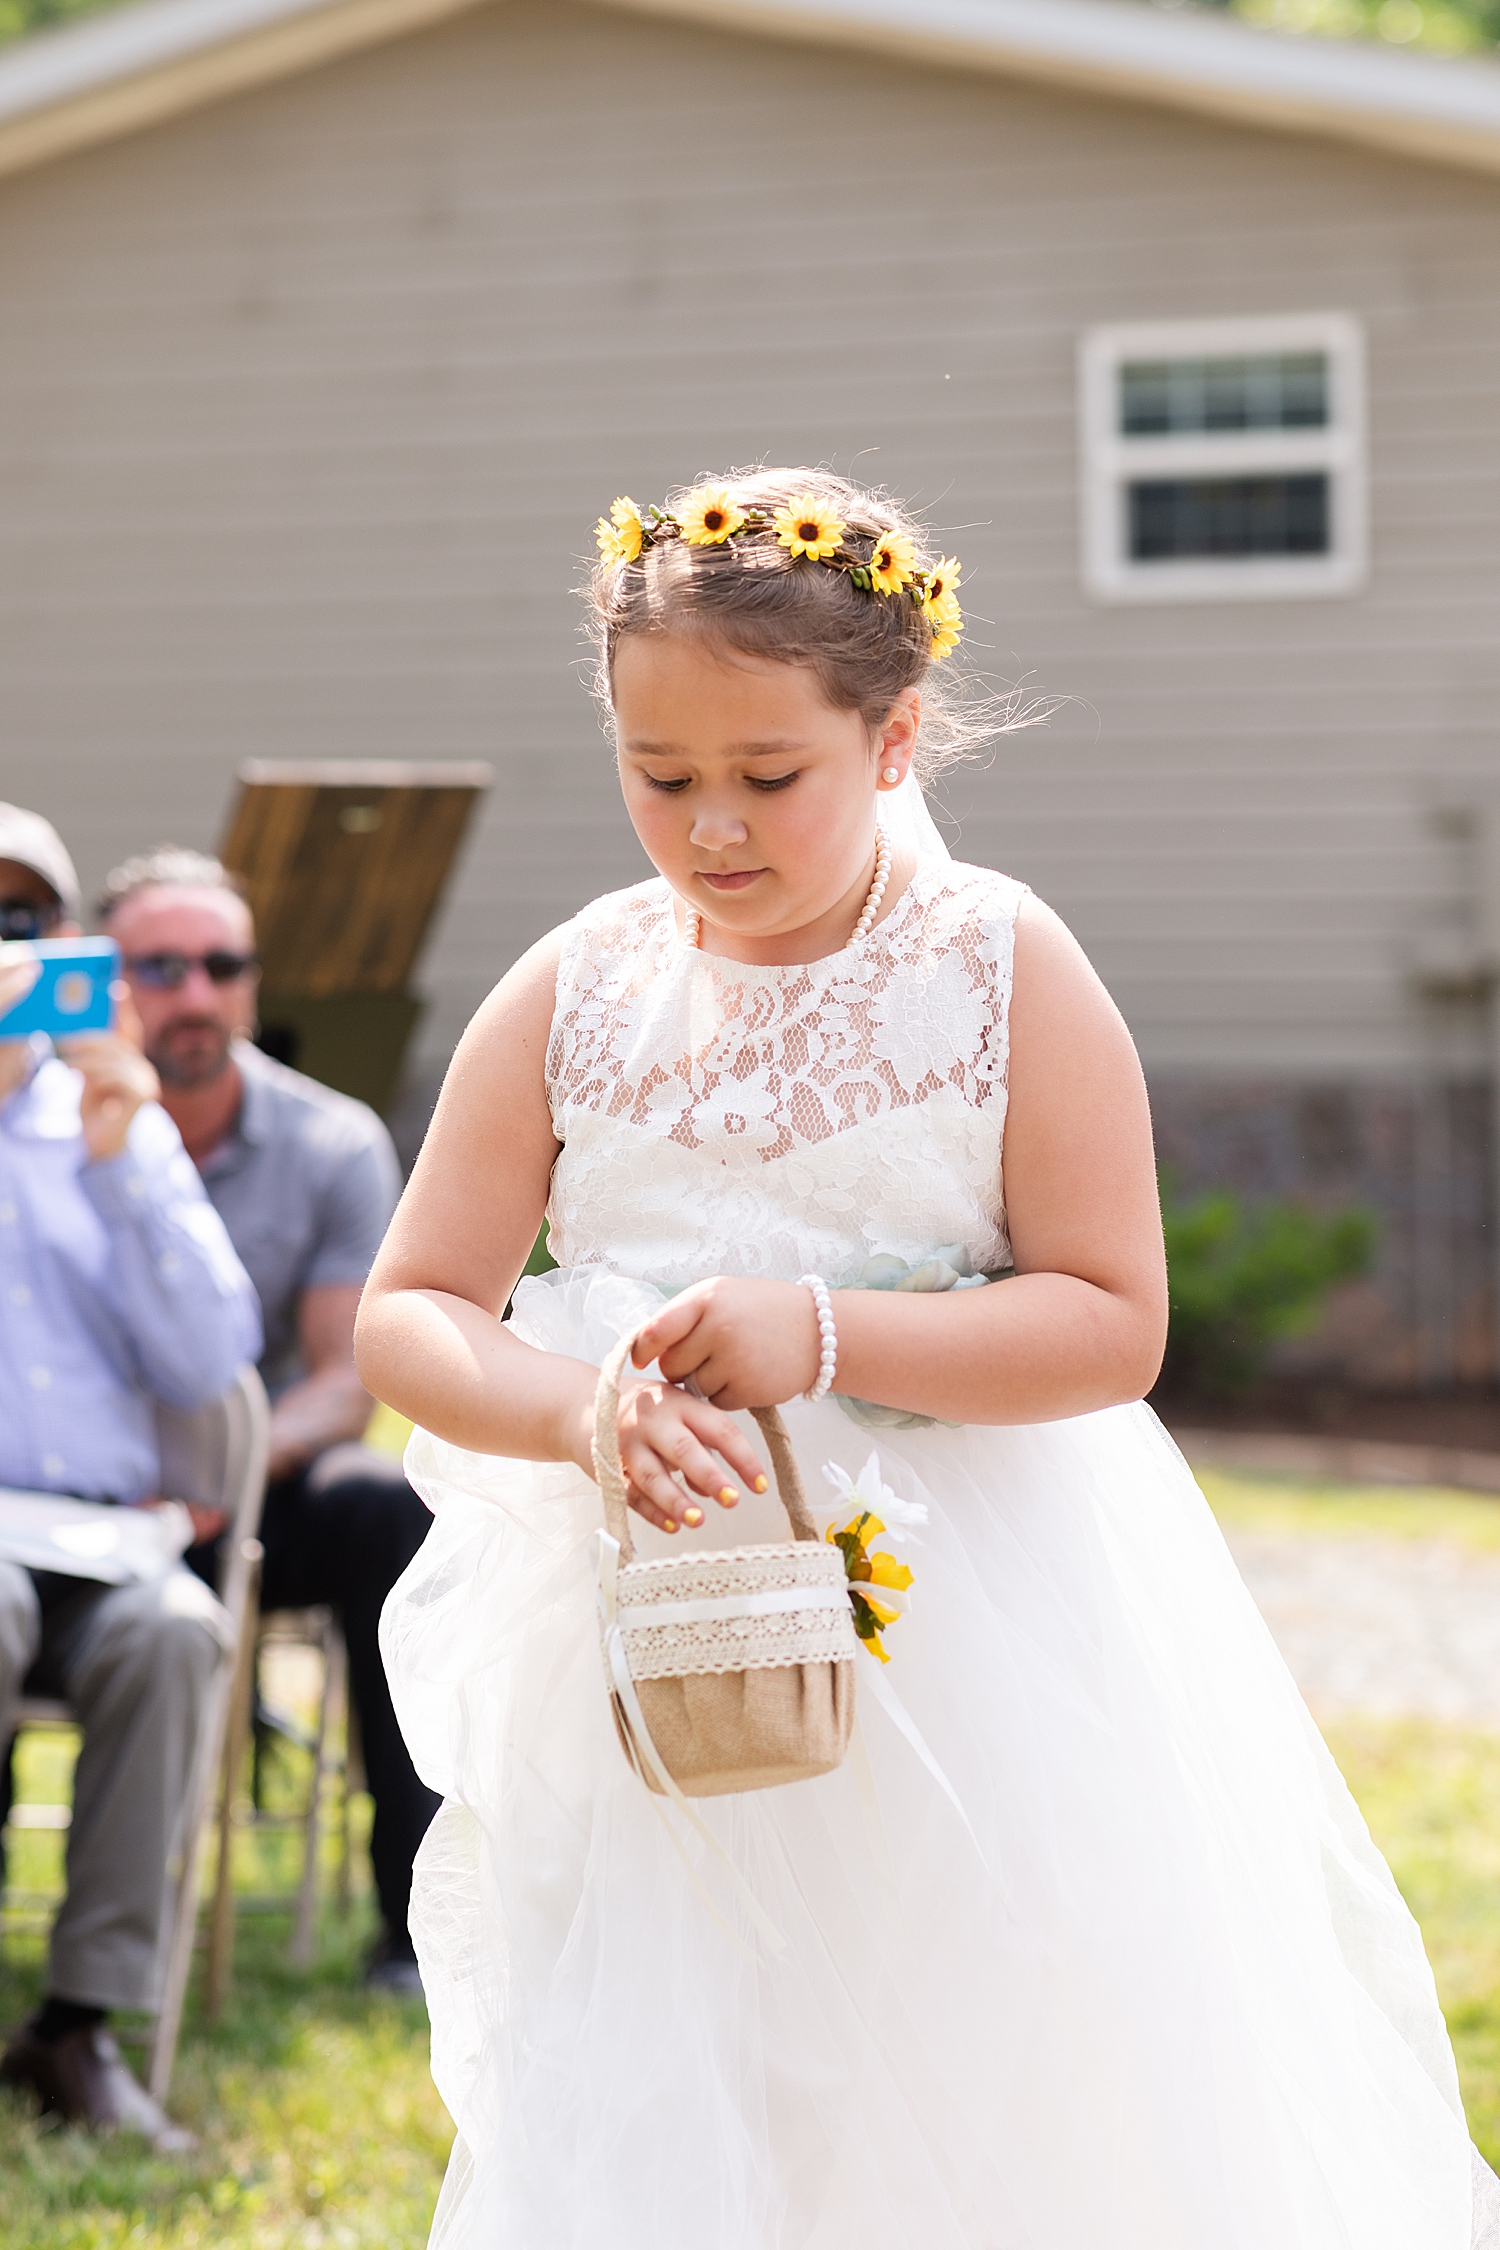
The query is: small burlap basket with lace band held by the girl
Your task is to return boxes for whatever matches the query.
[594,1337,859,1798]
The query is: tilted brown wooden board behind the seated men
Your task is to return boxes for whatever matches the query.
[220,761,490,999]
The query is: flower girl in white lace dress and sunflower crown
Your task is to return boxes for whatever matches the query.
[360,470,1496,2250]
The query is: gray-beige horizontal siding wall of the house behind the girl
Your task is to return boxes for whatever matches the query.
[0,0,1500,1125]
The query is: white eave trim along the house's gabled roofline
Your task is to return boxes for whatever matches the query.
[0,0,1500,189]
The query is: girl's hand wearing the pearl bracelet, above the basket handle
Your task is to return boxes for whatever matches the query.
[630,1274,821,1413]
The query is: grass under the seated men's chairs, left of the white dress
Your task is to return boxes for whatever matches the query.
[0,1701,452,2250]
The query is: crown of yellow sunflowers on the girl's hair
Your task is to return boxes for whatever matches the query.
[594,484,963,662]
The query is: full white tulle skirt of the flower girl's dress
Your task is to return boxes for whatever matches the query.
[382,1269,1498,2250]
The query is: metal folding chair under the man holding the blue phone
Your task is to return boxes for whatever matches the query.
[3,1368,270,2102]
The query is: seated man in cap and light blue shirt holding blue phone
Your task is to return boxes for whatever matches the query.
[0,806,261,2149]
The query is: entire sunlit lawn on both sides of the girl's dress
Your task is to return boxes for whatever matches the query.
[0,1458,1500,2250]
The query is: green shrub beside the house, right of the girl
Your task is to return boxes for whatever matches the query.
[1163,1179,1379,1391]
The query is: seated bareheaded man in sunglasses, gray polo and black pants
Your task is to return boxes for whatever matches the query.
[99,846,439,1996]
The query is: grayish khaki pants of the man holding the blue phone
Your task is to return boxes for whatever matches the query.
[0,1562,232,2009]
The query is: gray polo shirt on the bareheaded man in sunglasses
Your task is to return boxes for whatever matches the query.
[202,1040,400,1397]
